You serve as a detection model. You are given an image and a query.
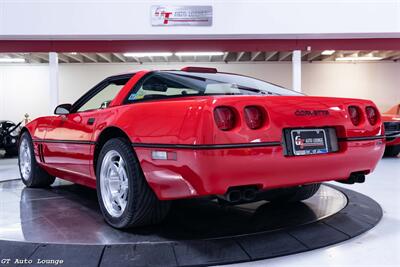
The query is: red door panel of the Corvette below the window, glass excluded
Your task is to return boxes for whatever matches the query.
[43,110,97,181]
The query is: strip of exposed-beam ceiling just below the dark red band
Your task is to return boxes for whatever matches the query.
[0,50,400,64]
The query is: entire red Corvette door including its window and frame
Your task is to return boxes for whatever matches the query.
[43,74,133,184]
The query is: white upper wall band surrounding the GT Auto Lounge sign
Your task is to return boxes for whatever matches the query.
[0,0,400,40]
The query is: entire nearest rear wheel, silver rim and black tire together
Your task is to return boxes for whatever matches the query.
[96,138,170,228]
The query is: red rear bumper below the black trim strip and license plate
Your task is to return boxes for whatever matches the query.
[134,139,385,200]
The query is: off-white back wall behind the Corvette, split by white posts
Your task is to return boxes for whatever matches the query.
[0,62,400,121]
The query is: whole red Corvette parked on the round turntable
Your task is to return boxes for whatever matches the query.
[19,67,385,228]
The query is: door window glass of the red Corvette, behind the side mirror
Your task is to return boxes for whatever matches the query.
[77,78,129,112]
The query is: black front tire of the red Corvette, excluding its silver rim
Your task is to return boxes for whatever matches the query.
[18,132,56,187]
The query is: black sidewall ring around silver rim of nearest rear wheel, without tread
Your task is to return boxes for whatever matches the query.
[96,139,137,228]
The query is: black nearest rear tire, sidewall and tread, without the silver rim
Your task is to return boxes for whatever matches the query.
[96,138,170,229]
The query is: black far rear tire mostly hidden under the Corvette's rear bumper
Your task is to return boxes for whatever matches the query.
[261,183,321,202]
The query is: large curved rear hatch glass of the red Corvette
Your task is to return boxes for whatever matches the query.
[128,71,302,102]
